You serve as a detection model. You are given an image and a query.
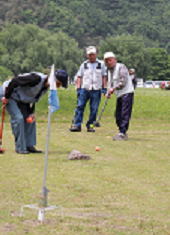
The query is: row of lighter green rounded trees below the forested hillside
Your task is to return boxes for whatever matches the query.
[0,24,170,81]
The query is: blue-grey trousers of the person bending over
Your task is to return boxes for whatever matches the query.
[6,99,36,151]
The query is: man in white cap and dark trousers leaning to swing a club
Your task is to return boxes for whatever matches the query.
[104,52,134,140]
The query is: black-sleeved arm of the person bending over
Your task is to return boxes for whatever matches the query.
[5,73,41,99]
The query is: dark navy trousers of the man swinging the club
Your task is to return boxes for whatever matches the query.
[115,93,134,134]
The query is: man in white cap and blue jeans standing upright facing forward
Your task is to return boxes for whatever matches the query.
[70,46,106,132]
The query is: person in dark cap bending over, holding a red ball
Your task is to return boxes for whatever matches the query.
[2,70,68,154]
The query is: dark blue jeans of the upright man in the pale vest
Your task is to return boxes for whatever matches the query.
[74,88,101,128]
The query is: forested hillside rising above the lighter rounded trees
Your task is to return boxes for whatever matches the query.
[0,0,170,49]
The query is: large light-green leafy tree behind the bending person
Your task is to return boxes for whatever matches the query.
[0,24,82,76]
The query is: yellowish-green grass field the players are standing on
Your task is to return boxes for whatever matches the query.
[0,88,170,235]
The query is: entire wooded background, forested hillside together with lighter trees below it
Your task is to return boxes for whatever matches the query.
[0,0,170,81]
